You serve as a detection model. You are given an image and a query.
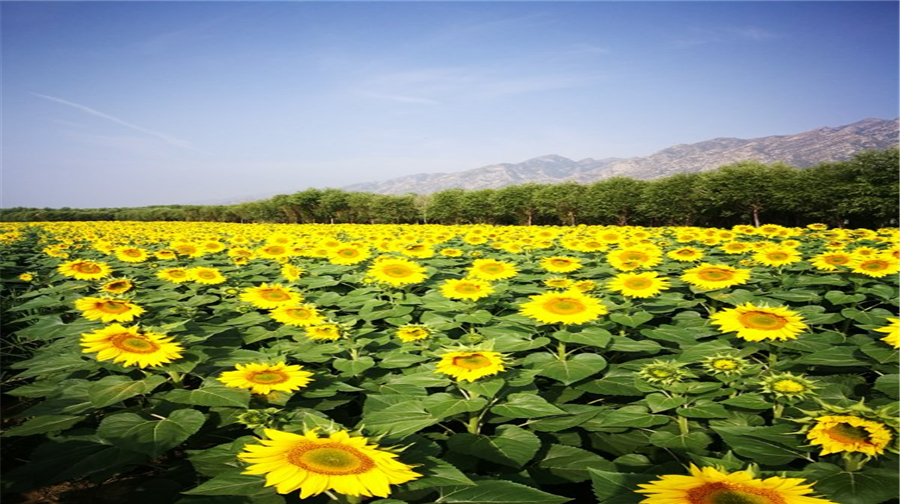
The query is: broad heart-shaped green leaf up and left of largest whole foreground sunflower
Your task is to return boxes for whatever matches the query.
[97,409,206,457]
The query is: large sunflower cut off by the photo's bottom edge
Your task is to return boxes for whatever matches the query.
[635,464,834,504]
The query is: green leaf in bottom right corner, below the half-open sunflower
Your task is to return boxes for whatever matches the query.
[799,463,900,504]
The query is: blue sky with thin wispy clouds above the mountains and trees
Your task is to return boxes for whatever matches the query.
[0,1,900,208]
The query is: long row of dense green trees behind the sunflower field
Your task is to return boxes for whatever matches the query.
[0,148,900,227]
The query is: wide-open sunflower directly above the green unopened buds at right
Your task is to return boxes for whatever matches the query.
[709,303,808,341]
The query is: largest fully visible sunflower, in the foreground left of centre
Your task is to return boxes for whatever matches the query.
[238,429,422,500]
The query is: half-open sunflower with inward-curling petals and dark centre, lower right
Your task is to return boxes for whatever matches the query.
[806,415,893,456]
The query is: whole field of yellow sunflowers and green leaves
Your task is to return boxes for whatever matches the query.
[0,222,900,504]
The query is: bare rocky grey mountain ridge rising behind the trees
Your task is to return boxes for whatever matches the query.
[343,119,900,194]
